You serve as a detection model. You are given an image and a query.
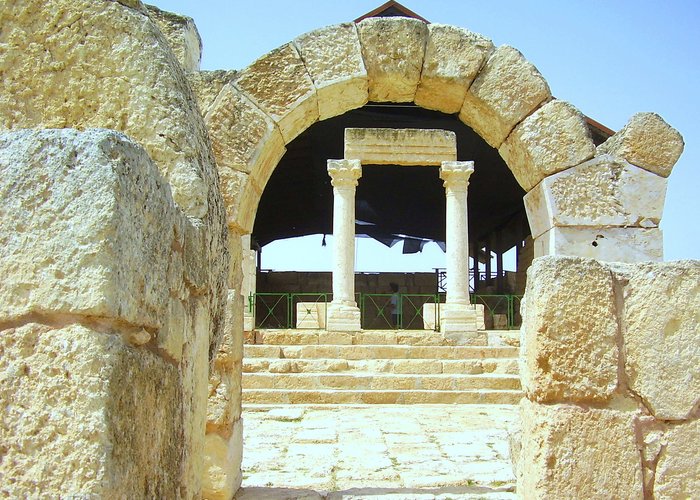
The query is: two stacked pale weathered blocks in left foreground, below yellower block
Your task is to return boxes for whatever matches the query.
[0,129,211,498]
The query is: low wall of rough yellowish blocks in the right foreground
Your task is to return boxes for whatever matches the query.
[515,257,700,498]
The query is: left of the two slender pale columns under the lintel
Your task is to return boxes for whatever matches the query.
[326,160,362,331]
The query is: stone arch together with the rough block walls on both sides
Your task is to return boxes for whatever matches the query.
[0,0,700,498]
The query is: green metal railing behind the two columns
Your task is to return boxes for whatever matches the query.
[248,292,522,330]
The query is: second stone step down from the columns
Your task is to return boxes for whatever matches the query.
[243,344,518,360]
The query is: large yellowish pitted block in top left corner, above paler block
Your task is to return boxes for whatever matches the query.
[0,0,220,217]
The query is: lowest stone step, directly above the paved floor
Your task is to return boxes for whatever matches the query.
[243,389,523,404]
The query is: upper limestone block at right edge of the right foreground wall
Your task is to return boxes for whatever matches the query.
[614,261,700,419]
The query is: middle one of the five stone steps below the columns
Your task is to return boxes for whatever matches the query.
[243,357,518,375]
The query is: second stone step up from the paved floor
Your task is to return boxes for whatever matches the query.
[243,373,520,391]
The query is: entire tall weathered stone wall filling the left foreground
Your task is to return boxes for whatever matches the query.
[0,0,231,498]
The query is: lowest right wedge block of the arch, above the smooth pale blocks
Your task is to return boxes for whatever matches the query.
[498,100,595,191]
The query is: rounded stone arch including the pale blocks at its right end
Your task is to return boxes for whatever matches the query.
[198,17,682,260]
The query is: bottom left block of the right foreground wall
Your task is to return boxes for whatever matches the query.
[517,399,643,499]
